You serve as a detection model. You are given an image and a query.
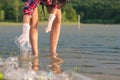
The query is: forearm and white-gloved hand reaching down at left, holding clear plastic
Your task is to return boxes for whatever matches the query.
[15,14,30,50]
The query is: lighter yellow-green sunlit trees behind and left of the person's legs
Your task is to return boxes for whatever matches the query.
[0,0,77,22]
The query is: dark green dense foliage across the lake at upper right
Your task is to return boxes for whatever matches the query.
[71,0,120,24]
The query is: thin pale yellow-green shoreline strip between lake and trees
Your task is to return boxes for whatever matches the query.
[0,21,120,28]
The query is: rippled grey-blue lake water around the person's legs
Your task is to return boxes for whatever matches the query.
[0,24,120,80]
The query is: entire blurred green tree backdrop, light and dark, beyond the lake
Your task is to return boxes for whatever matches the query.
[0,0,120,24]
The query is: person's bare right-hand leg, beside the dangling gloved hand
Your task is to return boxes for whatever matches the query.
[50,9,61,62]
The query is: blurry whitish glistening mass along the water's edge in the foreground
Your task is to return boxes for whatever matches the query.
[0,57,93,80]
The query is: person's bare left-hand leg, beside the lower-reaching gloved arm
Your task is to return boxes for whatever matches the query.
[30,8,38,57]
